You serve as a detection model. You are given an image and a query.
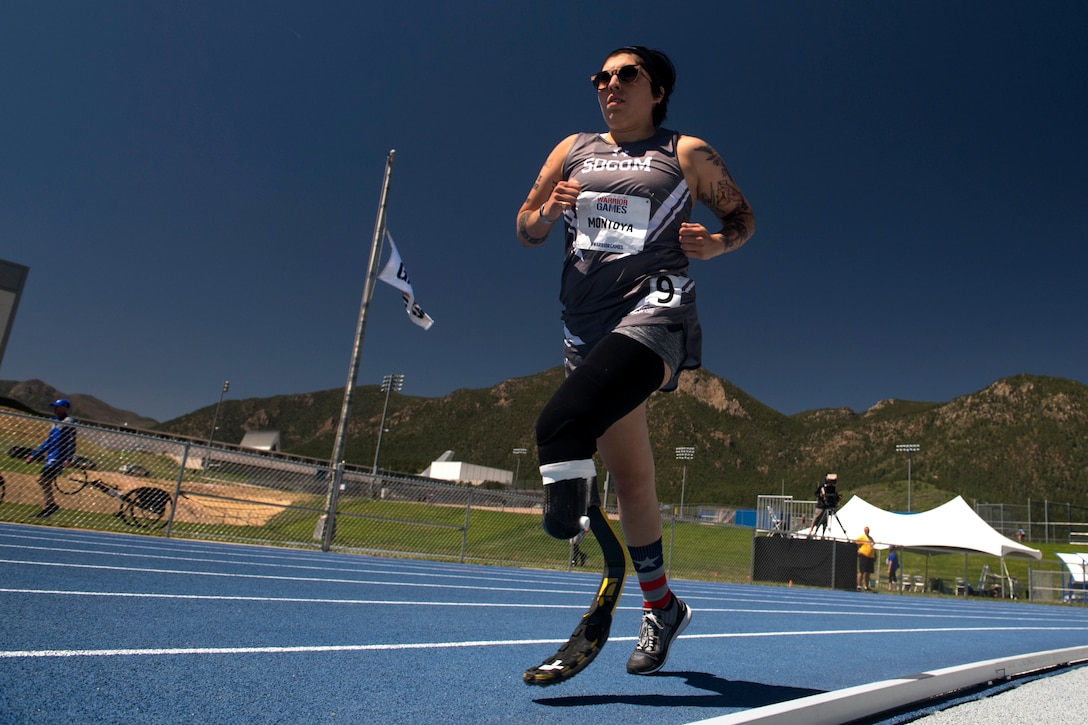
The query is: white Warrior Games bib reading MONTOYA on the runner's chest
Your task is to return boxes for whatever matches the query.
[574,192,650,255]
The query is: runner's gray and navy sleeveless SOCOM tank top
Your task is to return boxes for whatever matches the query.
[559,128,702,382]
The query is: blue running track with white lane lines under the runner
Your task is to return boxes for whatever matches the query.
[0,525,1088,725]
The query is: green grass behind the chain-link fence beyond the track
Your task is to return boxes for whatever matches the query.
[6,463,1076,595]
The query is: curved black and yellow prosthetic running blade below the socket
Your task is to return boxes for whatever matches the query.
[521,500,627,687]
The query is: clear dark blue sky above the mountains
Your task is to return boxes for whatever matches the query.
[0,0,1088,420]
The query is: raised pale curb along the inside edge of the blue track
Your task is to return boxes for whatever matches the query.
[690,647,1088,725]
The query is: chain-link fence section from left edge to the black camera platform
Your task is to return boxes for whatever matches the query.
[0,411,753,581]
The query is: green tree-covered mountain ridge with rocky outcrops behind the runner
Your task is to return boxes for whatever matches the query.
[0,367,1088,509]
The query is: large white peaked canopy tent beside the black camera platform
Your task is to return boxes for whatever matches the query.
[813,495,1042,595]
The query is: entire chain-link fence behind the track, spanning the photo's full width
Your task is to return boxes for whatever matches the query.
[8,411,1088,604]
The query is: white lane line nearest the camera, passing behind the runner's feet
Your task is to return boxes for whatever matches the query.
[0,627,1088,660]
